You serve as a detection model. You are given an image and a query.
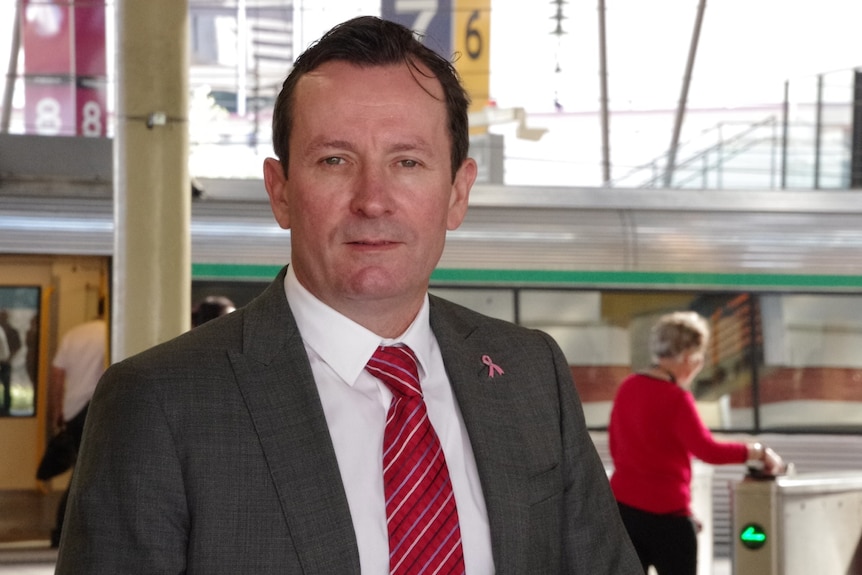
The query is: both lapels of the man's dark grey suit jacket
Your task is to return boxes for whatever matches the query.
[223,276,529,575]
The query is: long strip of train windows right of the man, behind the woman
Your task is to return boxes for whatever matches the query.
[431,287,862,433]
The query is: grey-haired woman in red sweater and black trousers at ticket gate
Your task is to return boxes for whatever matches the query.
[608,312,784,575]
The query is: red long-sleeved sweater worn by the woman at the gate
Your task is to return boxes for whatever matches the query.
[608,374,748,515]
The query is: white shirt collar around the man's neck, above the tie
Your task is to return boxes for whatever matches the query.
[284,266,434,385]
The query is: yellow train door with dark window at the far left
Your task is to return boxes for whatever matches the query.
[0,255,110,516]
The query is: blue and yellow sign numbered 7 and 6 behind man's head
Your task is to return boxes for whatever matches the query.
[381,0,491,110]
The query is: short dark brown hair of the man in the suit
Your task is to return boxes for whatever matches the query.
[272,16,470,180]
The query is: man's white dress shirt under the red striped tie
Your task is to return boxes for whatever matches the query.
[284,267,494,575]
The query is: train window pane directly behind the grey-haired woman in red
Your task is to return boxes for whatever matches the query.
[518,289,759,430]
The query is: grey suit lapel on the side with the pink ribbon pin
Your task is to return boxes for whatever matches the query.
[431,297,529,575]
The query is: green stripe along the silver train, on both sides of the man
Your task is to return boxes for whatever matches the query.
[192,264,862,290]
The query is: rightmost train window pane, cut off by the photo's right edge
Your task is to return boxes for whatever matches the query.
[759,295,862,430]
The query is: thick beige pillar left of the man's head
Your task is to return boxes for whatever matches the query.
[111,0,191,361]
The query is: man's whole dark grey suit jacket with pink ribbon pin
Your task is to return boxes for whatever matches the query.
[57,270,640,575]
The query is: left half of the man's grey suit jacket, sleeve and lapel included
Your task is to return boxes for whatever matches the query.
[57,271,359,575]
